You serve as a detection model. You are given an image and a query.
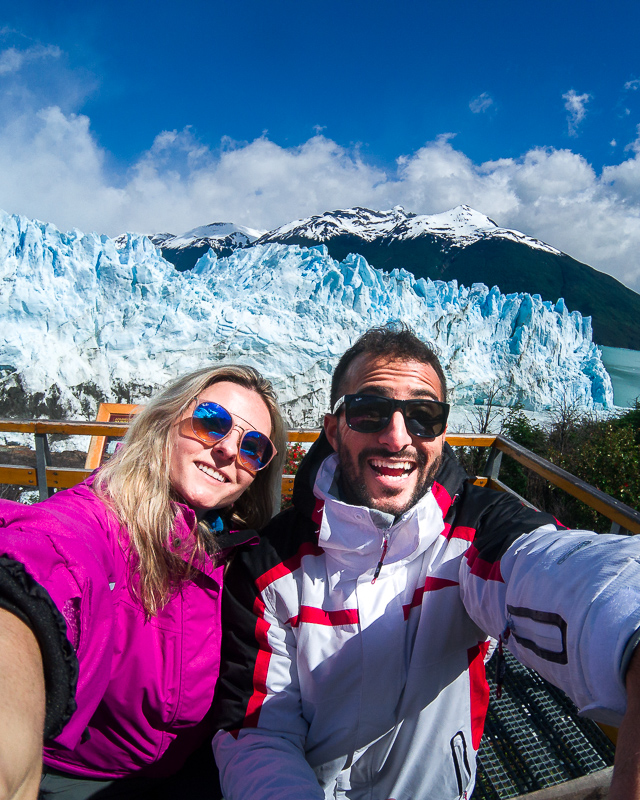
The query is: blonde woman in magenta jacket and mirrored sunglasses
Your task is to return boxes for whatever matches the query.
[0,366,286,800]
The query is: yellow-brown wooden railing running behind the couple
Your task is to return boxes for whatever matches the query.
[0,419,640,533]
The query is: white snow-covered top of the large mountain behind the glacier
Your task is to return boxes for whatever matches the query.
[257,205,560,255]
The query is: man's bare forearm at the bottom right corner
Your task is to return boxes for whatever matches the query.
[609,648,640,800]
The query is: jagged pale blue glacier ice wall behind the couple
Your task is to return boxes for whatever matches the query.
[0,212,613,427]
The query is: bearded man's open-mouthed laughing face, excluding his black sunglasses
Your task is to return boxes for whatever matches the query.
[324,355,446,517]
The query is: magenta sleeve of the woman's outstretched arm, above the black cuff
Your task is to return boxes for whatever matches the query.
[0,490,113,749]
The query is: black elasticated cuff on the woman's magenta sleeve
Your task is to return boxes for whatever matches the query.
[0,557,78,739]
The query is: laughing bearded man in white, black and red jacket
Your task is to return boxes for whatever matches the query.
[214,329,640,800]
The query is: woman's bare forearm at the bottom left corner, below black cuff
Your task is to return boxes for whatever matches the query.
[0,608,45,800]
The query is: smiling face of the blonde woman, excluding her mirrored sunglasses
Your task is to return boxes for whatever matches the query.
[169,381,271,514]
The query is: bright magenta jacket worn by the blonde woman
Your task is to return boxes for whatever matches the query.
[0,482,245,778]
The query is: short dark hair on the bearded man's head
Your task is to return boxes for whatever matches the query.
[331,324,447,408]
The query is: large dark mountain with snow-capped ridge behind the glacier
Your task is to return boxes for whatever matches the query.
[249,206,640,350]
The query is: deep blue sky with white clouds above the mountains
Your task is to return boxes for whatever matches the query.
[0,0,640,291]
